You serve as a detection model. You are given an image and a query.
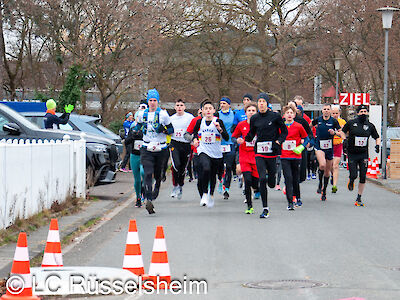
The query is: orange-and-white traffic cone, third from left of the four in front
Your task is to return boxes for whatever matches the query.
[122,220,144,276]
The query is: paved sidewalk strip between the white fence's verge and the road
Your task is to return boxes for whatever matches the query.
[0,173,133,278]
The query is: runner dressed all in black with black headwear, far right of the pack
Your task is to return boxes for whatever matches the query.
[343,105,381,206]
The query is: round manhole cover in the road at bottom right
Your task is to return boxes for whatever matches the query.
[243,279,327,290]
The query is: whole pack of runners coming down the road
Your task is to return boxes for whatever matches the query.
[125,89,380,218]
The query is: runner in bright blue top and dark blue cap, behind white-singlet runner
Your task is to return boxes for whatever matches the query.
[218,97,235,200]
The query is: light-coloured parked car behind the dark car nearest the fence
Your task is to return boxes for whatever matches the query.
[20,111,123,155]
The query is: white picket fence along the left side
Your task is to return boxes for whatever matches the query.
[0,135,86,229]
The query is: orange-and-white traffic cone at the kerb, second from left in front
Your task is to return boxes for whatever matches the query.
[42,219,63,267]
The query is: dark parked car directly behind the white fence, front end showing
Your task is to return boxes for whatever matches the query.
[0,104,119,184]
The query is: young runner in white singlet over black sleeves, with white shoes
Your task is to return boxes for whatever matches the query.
[189,101,230,208]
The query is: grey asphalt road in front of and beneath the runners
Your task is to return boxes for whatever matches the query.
[64,170,400,300]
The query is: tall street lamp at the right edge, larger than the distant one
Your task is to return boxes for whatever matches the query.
[377,6,399,179]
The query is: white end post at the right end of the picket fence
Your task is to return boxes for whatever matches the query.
[75,132,86,198]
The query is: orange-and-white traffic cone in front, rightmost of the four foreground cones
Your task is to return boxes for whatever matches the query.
[148,226,171,289]
